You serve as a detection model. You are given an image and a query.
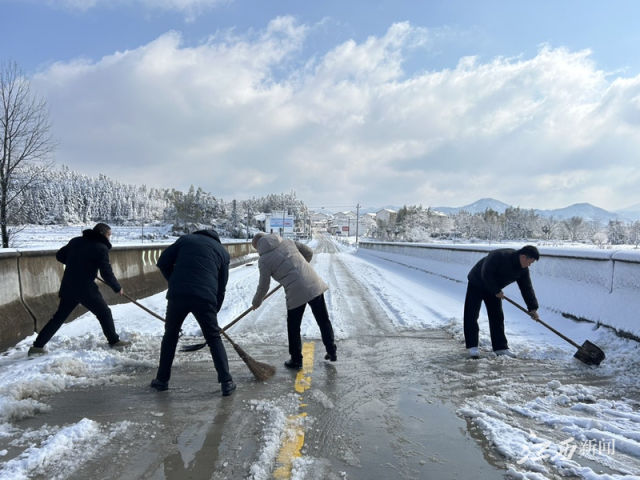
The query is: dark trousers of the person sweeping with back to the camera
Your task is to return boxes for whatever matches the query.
[156,297,231,383]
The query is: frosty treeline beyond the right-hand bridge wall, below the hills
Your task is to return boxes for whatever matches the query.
[376,205,640,247]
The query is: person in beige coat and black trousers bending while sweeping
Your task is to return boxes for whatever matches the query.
[253,232,338,370]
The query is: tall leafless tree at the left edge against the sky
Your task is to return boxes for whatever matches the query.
[0,62,57,248]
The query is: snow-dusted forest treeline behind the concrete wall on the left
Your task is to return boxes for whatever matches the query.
[11,167,306,238]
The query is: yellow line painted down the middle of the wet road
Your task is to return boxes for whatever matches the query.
[273,342,315,480]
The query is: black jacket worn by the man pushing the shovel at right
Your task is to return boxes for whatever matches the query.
[467,248,538,310]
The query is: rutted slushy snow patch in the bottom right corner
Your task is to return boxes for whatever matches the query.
[458,379,640,479]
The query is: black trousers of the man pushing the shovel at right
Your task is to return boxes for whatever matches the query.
[464,283,509,351]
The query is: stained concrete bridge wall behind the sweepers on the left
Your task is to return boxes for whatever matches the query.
[0,242,256,351]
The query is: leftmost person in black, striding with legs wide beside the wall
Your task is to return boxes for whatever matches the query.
[29,223,131,355]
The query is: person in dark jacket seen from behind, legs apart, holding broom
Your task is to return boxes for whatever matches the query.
[151,230,236,396]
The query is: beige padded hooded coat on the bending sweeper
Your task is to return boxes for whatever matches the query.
[253,233,329,310]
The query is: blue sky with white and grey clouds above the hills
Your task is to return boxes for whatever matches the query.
[0,0,640,210]
